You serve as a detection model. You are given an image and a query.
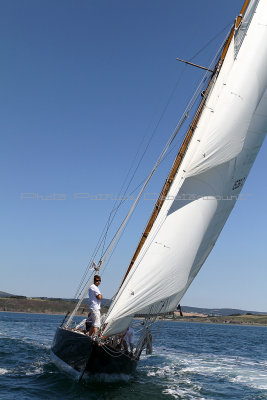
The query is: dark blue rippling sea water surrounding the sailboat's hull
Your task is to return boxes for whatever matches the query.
[0,312,267,400]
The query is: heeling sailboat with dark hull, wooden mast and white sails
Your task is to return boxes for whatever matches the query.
[52,0,267,379]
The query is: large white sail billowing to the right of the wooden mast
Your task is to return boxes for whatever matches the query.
[104,0,267,335]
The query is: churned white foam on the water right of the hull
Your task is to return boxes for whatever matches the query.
[147,347,267,398]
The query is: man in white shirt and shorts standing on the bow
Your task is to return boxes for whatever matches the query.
[88,275,102,336]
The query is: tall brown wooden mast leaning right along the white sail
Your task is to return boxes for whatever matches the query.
[120,0,250,287]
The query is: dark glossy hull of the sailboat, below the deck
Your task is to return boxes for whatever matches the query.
[51,328,137,375]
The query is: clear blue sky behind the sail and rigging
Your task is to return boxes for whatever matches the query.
[0,0,267,311]
